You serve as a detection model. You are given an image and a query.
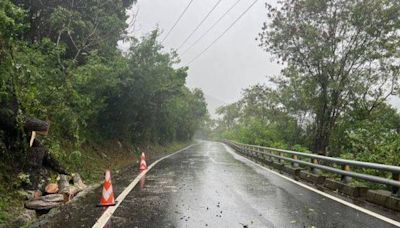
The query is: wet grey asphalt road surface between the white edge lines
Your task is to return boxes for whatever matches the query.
[107,142,393,228]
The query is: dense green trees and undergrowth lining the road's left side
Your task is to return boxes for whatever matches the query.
[0,0,208,223]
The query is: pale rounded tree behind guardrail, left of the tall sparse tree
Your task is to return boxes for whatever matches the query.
[215,85,303,148]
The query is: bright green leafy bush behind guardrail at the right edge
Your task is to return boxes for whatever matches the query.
[333,104,400,166]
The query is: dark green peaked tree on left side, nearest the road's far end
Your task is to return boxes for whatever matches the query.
[97,31,207,143]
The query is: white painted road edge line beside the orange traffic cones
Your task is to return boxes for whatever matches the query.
[92,144,196,228]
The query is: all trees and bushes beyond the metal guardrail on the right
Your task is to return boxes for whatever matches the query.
[216,0,400,165]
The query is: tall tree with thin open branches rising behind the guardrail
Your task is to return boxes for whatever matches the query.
[260,0,400,154]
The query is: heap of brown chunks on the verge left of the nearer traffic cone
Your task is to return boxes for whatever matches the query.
[25,174,86,210]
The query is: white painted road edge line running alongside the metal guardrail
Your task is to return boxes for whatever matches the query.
[222,143,400,227]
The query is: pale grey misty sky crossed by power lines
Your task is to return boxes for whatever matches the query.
[128,0,281,108]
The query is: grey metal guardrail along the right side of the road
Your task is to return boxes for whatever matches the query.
[224,140,400,194]
